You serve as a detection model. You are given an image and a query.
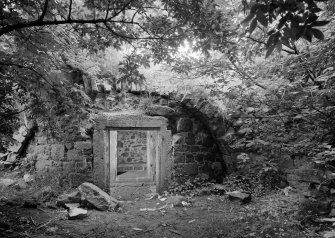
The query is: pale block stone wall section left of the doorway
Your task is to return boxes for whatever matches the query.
[26,133,93,187]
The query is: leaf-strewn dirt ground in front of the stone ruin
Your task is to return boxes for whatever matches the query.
[0,191,319,238]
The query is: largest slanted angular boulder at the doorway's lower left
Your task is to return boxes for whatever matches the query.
[78,183,118,211]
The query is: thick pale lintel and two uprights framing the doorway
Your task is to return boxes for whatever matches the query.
[93,113,172,192]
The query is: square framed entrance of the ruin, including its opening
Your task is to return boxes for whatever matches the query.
[93,113,172,192]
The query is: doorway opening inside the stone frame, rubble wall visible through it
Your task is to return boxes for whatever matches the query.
[109,128,159,184]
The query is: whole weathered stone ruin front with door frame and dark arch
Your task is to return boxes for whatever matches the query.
[27,90,234,191]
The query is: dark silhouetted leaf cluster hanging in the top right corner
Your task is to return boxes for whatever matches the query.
[242,0,329,57]
